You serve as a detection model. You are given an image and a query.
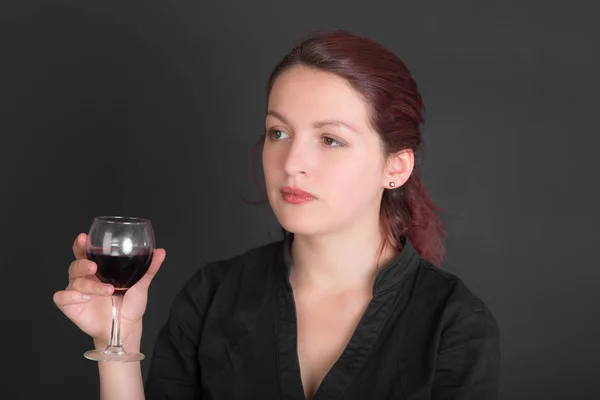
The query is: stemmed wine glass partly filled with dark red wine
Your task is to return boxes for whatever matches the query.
[84,216,154,362]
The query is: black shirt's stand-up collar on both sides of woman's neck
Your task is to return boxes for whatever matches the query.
[282,232,420,295]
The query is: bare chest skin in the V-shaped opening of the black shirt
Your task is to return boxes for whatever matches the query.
[296,293,371,399]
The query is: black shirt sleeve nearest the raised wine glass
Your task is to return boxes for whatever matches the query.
[145,266,215,400]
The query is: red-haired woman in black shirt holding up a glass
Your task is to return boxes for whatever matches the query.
[54,31,500,400]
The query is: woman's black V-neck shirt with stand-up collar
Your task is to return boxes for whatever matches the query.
[145,234,500,400]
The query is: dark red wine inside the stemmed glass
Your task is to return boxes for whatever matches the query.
[87,249,152,294]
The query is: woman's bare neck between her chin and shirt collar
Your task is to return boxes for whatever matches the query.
[290,220,398,292]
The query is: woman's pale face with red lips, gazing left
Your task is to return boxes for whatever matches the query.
[262,66,389,235]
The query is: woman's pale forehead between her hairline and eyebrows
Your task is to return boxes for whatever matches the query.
[268,66,369,130]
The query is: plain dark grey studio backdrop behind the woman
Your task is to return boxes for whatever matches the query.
[0,0,600,399]
